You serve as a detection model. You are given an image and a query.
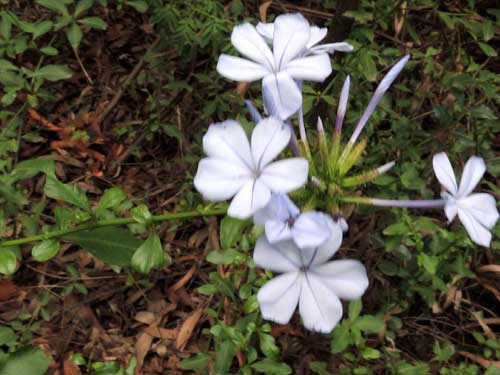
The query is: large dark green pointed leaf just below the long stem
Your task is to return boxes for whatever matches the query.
[64,227,141,267]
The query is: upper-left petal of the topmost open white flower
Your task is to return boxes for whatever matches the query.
[231,23,274,71]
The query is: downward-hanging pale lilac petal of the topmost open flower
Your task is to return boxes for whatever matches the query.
[262,72,302,120]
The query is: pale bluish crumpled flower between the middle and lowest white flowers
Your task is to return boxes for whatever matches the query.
[253,194,342,248]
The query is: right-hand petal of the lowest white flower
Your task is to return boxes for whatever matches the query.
[308,259,368,300]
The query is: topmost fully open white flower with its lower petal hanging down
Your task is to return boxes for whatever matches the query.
[217,13,332,120]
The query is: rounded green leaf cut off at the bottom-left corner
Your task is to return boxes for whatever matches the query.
[0,346,52,375]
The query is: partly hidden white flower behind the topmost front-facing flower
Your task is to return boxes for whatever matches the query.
[256,22,354,56]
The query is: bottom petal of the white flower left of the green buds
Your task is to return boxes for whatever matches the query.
[227,179,271,219]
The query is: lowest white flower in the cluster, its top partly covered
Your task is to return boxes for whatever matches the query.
[253,226,368,333]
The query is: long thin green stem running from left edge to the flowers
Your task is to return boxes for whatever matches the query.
[0,208,227,247]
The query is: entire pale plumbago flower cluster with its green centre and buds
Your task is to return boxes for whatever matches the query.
[194,14,499,333]
